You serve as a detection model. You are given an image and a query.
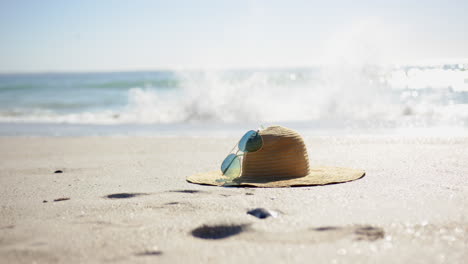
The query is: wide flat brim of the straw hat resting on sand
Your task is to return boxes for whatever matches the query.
[187,167,366,188]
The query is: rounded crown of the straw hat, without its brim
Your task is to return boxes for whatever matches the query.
[241,126,309,177]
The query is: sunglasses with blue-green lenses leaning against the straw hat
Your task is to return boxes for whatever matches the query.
[221,130,263,179]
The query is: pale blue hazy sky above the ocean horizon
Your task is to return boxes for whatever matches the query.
[0,0,468,72]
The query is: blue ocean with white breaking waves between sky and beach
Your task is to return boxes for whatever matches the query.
[0,64,468,136]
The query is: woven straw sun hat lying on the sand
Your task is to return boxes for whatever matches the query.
[187,126,365,187]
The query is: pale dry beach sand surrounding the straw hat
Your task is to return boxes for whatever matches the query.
[0,137,468,263]
